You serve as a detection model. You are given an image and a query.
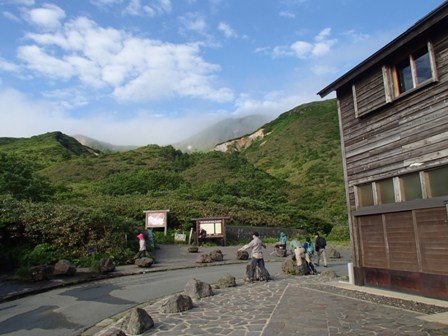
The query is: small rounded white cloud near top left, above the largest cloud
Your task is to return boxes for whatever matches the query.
[25,4,65,31]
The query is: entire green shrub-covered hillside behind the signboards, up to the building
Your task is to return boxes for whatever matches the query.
[0,100,347,270]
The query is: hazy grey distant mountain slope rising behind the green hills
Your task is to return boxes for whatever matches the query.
[173,115,268,152]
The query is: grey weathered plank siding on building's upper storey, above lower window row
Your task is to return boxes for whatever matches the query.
[337,30,448,210]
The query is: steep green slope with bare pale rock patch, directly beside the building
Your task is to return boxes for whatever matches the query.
[215,99,346,221]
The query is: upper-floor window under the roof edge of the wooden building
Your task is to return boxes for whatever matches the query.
[392,43,437,97]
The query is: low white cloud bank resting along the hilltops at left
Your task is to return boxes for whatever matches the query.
[0,87,222,146]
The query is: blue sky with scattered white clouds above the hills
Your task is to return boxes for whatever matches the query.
[0,0,444,146]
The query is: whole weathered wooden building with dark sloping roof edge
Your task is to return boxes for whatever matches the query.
[318,2,448,300]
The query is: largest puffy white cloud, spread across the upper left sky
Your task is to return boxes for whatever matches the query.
[18,17,233,102]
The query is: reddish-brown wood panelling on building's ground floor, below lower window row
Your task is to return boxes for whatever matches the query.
[354,207,448,299]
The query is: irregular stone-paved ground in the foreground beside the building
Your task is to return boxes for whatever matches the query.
[98,277,448,336]
